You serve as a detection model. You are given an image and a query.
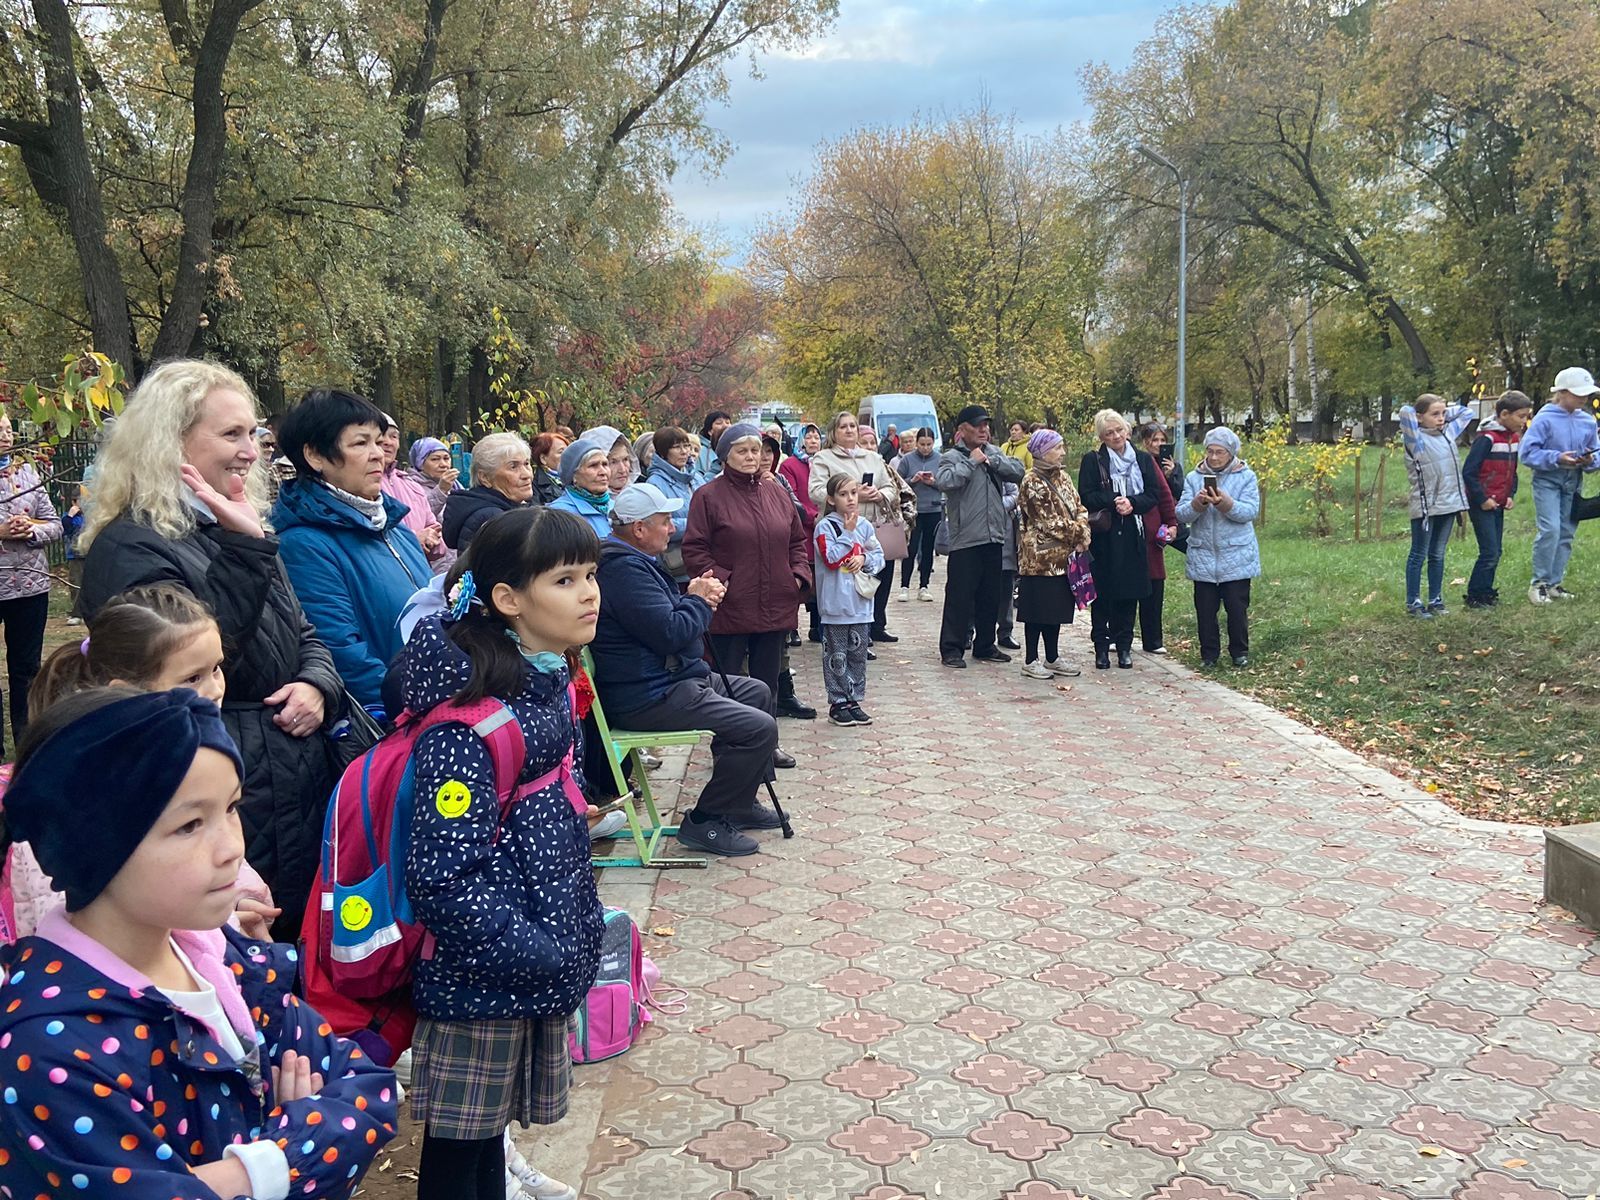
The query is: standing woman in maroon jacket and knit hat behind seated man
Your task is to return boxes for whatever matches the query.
[683,424,811,766]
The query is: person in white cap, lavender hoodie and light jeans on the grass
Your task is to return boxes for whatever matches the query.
[1518,366,1600,605]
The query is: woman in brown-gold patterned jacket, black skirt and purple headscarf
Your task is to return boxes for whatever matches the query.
[1016,429,1090,678]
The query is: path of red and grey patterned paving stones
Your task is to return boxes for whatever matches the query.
[579,603,1600,1200]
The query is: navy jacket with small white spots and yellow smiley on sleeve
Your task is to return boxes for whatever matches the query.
[396,618,603,1021]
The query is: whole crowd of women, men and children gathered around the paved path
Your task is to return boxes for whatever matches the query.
[0,360,1600,1200]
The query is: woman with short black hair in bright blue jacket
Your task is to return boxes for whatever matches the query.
[272,389,434,712]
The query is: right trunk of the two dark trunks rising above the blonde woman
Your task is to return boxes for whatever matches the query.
[150,0,261,362]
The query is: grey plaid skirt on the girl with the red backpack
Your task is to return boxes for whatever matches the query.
[410,1016,573,1141]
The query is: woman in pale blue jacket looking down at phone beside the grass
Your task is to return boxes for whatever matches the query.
[1178,426,1261,667]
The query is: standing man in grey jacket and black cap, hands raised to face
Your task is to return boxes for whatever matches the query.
[934,405,1022,667]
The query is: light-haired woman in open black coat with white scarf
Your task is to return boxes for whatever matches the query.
[1078,408,1160,670]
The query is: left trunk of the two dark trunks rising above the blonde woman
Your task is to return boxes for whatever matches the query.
[30,0,142,382]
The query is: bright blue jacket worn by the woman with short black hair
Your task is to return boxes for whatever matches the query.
[272,478,434,707]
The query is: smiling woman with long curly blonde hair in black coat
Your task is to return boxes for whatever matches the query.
[80,360,344,941]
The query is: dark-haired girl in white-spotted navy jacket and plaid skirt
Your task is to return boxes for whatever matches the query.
[400,509,603,1200]
